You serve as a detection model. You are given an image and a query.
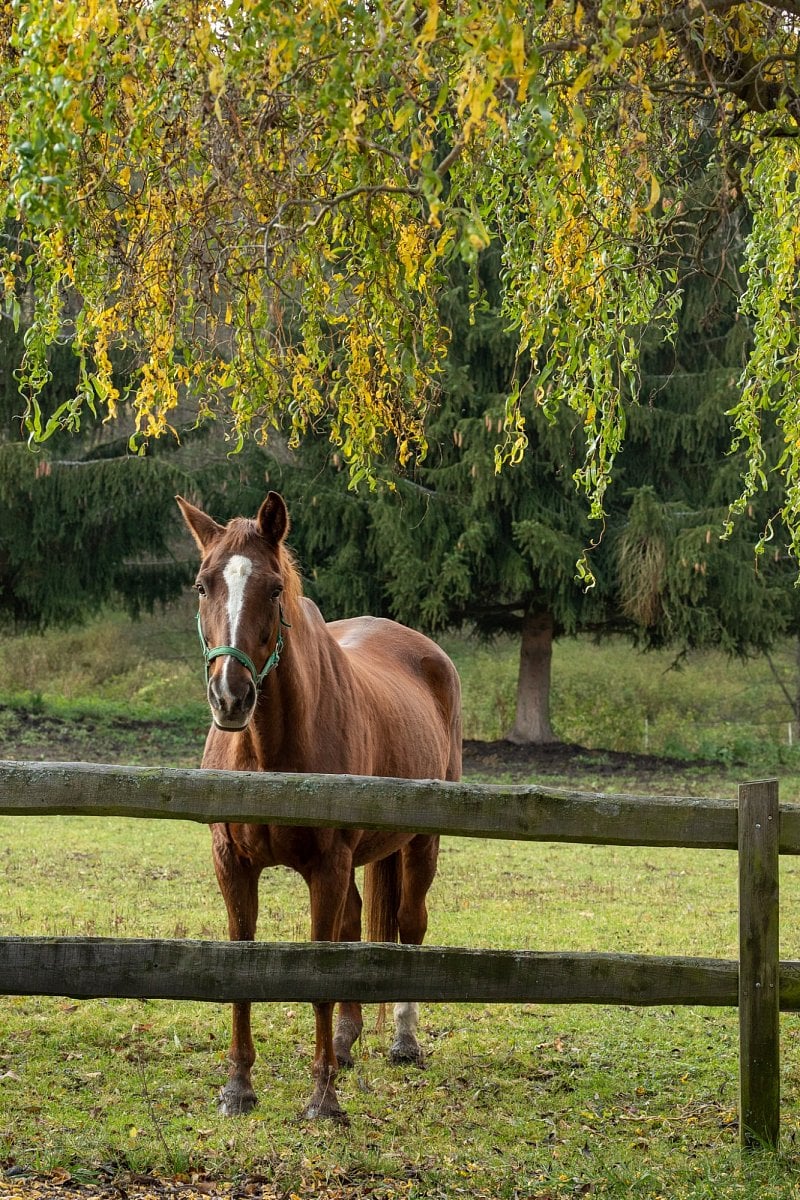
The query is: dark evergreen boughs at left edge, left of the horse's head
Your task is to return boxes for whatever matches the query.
[0,319,188,629]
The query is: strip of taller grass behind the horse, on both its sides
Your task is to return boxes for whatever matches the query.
[0,598,800,775]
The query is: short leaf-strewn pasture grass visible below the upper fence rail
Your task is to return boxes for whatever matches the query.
[0,817,800,1200]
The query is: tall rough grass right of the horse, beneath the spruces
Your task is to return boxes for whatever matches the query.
[443,637,800,763]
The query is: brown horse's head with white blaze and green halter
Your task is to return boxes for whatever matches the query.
[175,492,290,731]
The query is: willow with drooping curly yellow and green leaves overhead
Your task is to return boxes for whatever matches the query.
[0,0,800,550]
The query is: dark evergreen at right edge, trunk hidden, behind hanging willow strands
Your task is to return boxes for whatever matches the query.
[609,194,798,656]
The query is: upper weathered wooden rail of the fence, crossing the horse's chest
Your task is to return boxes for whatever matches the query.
[6,762,800,854]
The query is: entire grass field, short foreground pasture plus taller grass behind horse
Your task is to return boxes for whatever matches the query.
[0,611,800,1200]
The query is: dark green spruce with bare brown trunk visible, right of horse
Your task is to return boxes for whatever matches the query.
[369,274,621,743]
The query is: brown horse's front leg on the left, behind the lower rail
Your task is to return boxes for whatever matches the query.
[211,826,259,1117]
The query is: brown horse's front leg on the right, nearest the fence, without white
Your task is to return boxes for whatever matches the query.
[303,856,353,1124]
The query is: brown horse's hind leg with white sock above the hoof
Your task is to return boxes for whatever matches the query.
[389,834,439,1067]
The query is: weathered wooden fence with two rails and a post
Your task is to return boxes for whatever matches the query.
[0,762,800,1146]
